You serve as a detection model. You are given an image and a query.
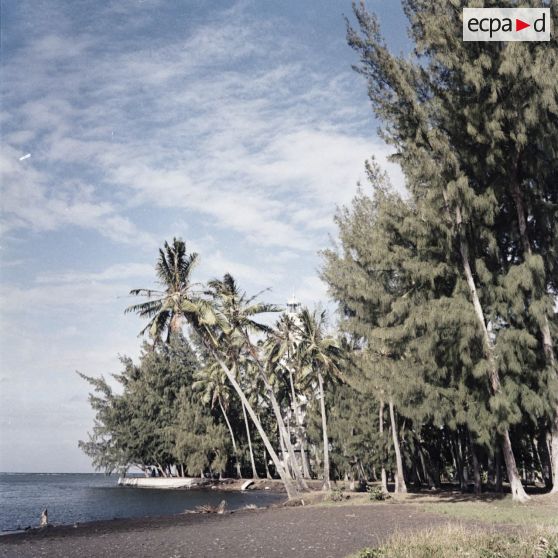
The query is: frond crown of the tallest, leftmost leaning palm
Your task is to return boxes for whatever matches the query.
[125,238,198,342]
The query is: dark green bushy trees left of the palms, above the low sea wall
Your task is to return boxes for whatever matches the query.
[80,335,228,475]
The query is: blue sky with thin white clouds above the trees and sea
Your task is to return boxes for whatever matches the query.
[0,0,409,472]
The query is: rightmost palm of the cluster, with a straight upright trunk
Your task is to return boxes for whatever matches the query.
[297,308,343,490]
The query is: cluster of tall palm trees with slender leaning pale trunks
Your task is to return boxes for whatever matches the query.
[126,238,343,498]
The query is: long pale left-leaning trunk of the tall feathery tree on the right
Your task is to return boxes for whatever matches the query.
[457,209,529,502]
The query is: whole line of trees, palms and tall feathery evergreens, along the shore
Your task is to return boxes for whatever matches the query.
[77,0,558,501]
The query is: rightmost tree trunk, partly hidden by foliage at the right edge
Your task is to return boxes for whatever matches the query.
[512,175,558,494]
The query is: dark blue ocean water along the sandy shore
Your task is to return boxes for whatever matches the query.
[0,473,283,532]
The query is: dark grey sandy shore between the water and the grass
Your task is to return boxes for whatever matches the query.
[0,502,464,558]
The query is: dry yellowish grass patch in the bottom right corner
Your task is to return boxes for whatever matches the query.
[349,525,558,558]
